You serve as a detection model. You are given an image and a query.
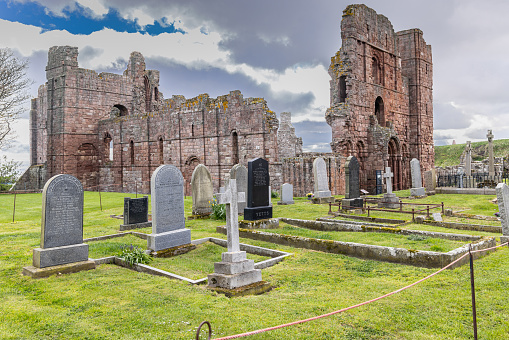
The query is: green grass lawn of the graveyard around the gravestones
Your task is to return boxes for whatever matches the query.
[0,191,509,339]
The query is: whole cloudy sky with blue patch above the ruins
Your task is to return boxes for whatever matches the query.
[0,0,509,170]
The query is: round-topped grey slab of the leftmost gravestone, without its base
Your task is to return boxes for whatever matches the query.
[41,174,83,248]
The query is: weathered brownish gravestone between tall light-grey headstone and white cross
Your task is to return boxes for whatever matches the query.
[191,164,214,216]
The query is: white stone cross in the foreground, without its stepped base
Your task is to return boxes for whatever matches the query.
[217,179,246,253]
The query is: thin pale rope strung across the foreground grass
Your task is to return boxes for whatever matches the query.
[207,242,509,340]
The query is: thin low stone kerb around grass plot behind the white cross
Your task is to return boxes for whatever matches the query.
[83,231,293,284]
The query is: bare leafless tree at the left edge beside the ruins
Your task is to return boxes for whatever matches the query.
[0,48,32,149]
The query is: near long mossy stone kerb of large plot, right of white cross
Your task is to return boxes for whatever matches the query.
[216,227,496,269]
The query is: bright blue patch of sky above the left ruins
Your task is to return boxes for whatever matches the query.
[0,1,185,36]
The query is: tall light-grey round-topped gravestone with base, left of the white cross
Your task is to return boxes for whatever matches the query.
[147,165,191,251]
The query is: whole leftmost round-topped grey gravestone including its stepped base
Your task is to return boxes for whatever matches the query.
[23,175,95,277]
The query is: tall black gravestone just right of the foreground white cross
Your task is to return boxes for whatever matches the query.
[244,158,272,221]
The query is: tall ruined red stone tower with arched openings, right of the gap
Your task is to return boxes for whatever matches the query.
[325,5,433,193]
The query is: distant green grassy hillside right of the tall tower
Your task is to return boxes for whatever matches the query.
[435,139,509,167]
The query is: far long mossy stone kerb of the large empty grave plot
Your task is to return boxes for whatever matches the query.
[281,218,481,241]
